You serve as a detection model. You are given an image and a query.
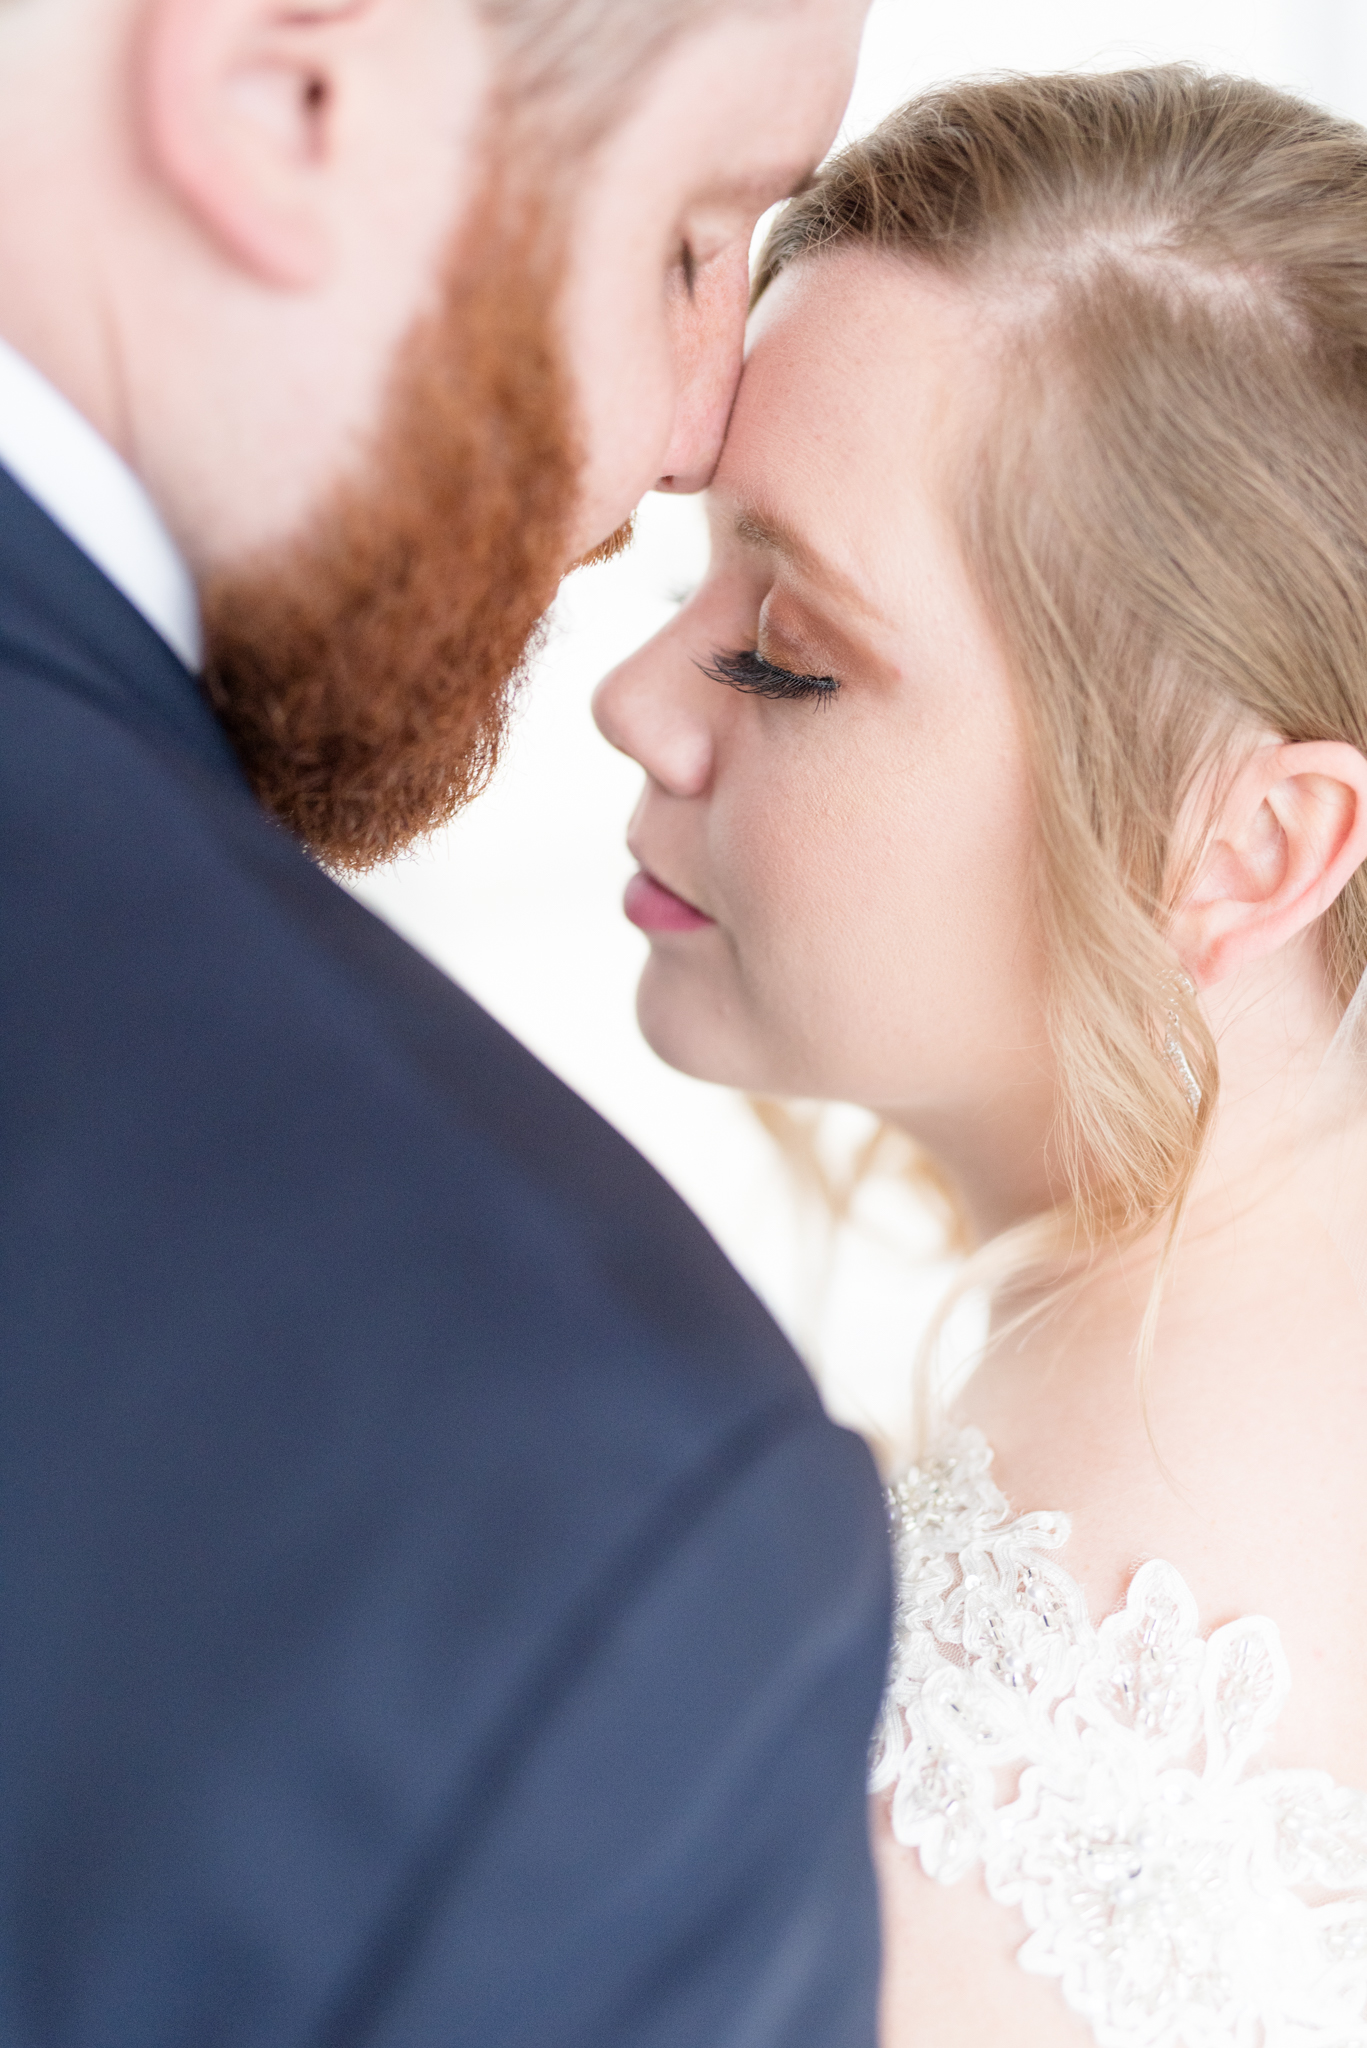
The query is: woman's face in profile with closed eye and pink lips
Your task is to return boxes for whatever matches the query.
[596,250,1051,1221]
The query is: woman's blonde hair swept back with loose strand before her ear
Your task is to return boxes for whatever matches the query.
[754,66,1367,1376]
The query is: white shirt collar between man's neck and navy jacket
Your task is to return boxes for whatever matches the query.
[0,340,203,670]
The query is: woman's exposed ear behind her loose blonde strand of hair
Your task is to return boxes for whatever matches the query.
[1170,739,1367,987]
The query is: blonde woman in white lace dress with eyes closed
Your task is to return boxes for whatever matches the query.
[598,70,1367,2048]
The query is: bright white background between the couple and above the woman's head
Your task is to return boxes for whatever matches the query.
[359,0,1367,1436]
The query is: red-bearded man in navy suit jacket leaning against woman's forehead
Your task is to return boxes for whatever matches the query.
[0,0,887,2048]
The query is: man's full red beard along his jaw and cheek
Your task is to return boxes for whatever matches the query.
[201,207,578,872]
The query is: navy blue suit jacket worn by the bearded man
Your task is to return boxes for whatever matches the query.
[0,473,887,2048]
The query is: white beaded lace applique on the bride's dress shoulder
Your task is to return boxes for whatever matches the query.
[871,1430,1367,2048]
